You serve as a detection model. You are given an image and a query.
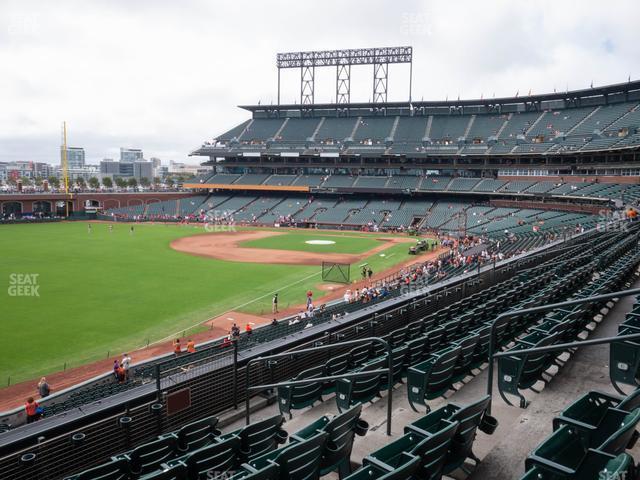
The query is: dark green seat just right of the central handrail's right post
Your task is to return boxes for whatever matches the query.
[407,345,462,412]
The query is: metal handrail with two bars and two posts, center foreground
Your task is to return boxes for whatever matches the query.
[245,337,393,436]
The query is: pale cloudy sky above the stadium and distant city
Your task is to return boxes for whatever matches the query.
[0,0,640,163]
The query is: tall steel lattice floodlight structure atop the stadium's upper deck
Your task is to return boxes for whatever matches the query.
[276,47,413,107]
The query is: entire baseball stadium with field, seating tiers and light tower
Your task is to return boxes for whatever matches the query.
[0,18,640,480]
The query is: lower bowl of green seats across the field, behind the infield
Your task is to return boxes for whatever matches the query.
[108,195,598,236]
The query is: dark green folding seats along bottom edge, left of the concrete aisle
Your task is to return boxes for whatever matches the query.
[65,390,495,480]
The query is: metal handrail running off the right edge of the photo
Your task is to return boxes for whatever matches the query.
[487,288,640,413]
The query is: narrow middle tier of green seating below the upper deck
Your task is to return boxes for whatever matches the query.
[190,173,640,200]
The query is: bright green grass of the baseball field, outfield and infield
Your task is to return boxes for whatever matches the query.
[0,222,424,385]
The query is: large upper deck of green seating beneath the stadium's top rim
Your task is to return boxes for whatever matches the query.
[205,101,640,154]
